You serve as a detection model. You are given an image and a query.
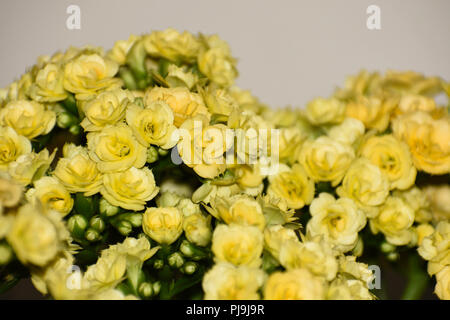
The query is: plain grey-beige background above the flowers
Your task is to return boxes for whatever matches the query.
[0,0,450,107]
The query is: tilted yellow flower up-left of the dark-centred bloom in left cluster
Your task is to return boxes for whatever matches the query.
[81,89,134,131]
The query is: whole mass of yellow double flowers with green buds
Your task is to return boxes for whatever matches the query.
[0,29,450,300]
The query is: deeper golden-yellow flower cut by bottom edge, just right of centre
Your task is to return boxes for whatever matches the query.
[264,269,326,300]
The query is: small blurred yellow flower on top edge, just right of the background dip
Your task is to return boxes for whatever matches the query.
[305,98,345,125]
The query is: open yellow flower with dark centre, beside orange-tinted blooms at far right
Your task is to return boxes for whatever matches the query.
[359,134,417,190]
